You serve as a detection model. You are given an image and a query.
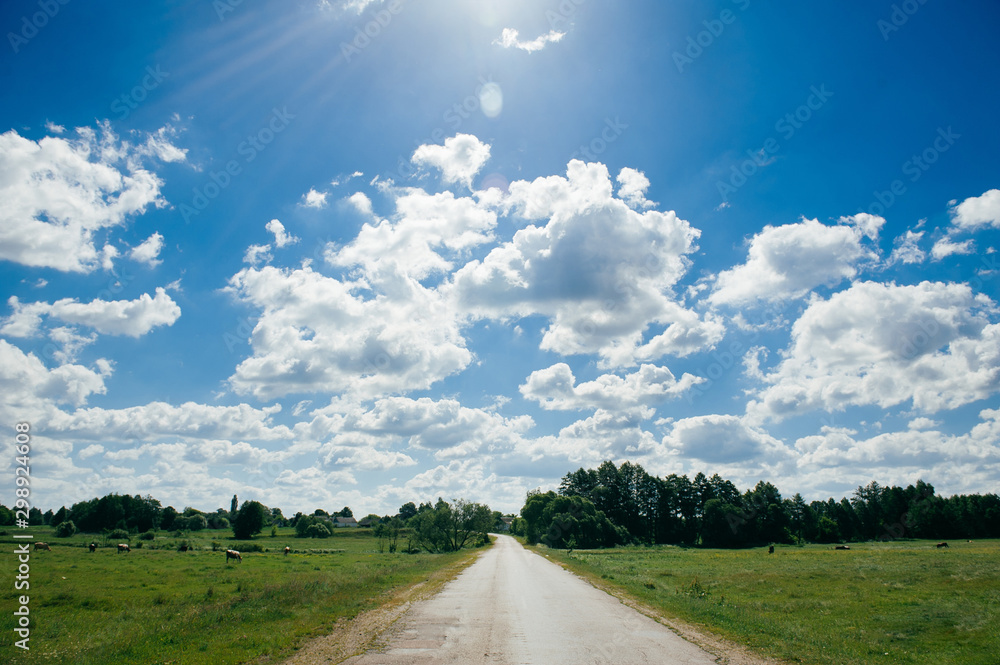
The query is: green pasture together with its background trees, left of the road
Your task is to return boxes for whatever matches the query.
[0,494,503,665]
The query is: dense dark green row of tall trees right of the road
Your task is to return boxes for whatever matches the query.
[513,462,1000,548]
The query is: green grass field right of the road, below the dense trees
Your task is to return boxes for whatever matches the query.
[540,540,1000,665]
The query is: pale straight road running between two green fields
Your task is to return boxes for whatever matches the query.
[345,536,716,665]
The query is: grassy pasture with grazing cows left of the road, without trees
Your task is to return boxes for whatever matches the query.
[0,527,482,665]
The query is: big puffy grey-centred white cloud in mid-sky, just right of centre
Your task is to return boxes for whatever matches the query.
[452,160,723,367]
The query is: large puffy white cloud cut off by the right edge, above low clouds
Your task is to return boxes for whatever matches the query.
[747,282,1000,420]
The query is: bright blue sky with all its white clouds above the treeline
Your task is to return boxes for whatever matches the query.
[0,0,1000,514]
